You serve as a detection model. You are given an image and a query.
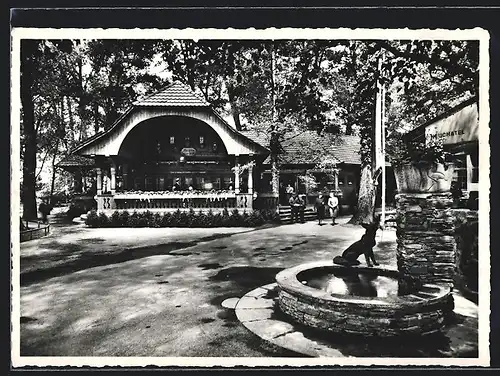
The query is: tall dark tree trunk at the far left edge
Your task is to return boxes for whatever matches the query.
[21,40,38,219]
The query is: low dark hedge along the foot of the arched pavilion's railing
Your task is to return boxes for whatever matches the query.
[85,209,280,228]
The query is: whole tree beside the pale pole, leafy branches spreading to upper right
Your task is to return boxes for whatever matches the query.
[336,40,479,223]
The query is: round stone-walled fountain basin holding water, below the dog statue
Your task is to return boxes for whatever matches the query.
[276,262,453,337]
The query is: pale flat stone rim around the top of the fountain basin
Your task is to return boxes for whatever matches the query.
[276,261,451,307]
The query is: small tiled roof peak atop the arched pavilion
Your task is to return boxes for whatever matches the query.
[134,81,210,107]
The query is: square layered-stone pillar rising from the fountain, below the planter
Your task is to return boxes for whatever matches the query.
[396,192,457,287]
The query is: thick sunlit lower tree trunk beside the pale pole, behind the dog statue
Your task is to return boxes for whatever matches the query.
[349,165,377,224]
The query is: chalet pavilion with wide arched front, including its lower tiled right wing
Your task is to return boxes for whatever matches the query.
[59,82,394,211]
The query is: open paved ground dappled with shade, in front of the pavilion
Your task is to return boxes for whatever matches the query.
[16,218,476,357]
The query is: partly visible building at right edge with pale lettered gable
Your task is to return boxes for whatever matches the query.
[405,97,479,197]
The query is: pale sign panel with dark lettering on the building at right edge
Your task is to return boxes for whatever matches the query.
[425,103,479,145]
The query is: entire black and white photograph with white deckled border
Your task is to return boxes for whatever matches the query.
[11,28,490,366]
